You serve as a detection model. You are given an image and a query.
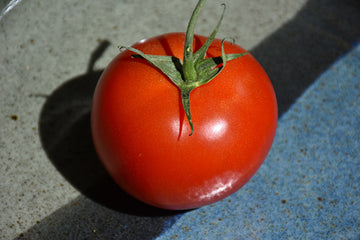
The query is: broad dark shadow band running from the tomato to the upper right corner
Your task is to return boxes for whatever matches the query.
[250,0,360,116]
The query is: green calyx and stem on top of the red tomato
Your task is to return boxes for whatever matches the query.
[120,0,247,136]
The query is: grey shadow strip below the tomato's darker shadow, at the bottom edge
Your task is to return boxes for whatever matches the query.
[16,196,177,240]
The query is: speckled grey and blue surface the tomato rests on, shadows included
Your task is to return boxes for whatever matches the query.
[0,0,360,240]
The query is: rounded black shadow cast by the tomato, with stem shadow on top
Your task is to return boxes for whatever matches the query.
[39,41,184,216]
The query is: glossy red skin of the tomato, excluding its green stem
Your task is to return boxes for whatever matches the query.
[91,33,277,210]
